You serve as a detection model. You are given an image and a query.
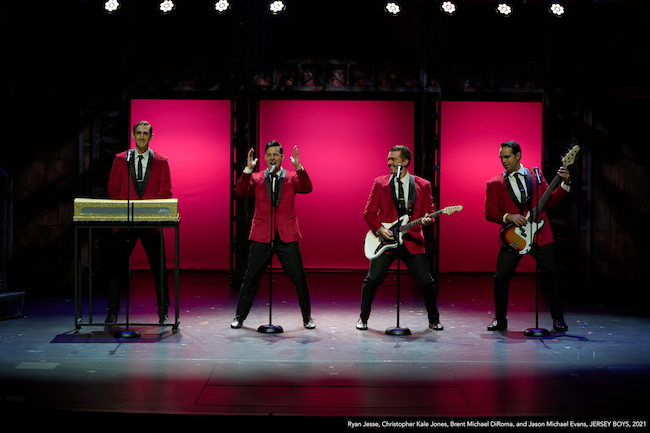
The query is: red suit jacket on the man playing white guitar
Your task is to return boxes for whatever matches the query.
[363,174,433,254]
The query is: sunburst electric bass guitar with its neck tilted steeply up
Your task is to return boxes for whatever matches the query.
[501,146,580,255]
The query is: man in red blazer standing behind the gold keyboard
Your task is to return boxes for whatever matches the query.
[106,120,172,323]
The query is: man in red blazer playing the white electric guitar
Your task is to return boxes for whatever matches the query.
[357,145,444,331]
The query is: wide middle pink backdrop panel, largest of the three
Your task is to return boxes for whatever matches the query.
[257,101,414,266]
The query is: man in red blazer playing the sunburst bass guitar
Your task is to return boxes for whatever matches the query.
[485,141,570,331]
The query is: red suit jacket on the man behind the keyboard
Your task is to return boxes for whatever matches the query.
[108,149,172,200]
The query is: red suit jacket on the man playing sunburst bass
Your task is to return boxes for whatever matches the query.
[485,166,568,248]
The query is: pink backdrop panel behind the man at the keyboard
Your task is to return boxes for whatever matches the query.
[130,99,230,270]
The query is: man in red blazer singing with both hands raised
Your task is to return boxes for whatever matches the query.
[230,141,316,329]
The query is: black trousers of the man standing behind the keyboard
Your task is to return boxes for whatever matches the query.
[108,229,170,315]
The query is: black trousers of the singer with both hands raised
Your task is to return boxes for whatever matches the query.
[236,240,311,322]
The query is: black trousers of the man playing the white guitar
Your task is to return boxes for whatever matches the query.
[360,244,440,323]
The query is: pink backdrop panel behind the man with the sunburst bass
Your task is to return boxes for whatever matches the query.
[440,101,540,272]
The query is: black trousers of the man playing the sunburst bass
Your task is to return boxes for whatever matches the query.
[494,244,564,320]
